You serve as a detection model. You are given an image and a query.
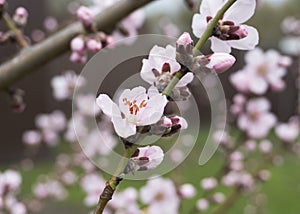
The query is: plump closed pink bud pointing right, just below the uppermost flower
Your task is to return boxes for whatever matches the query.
[206,53,235,73]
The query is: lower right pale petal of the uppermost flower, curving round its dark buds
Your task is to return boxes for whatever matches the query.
[227,25,259,50]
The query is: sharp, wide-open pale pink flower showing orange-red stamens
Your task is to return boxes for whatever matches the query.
[96,87,168,138]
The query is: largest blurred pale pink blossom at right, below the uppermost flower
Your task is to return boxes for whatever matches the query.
[230,48,292,95]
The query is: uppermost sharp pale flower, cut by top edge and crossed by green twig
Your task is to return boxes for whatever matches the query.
[192,0,258,53]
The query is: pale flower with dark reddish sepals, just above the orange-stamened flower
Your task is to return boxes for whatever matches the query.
[141,45,194,88]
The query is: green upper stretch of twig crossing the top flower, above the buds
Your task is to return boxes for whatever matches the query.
[193,0,237,55]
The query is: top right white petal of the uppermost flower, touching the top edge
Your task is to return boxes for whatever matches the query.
[223,0,256,24]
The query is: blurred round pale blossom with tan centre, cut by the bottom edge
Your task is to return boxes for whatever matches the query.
[140,178,180,214]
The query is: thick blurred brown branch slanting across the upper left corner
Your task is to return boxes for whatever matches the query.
[0,0,158,89]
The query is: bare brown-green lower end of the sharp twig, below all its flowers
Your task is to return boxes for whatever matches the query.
[94,144,138,214]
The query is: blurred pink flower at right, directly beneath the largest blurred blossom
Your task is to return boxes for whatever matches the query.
[238,98,276,138]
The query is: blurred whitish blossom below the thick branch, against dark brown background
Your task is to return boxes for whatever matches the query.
[51,71,85,100]
